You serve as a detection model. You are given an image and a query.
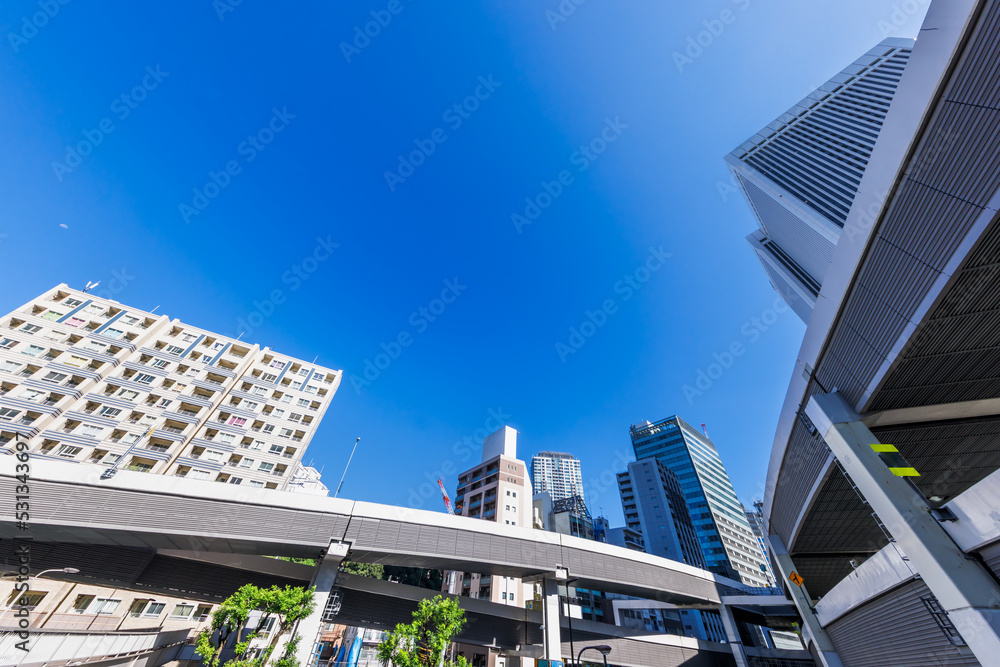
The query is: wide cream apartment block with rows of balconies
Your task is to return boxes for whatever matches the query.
[0,285,342,489]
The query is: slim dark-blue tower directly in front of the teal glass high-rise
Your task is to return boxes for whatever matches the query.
[618,459,705,569]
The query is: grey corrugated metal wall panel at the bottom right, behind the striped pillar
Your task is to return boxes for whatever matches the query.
[826,580,980,667]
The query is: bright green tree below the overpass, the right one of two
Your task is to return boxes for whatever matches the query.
[377,595,469,667]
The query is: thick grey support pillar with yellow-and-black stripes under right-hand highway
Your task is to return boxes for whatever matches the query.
[806,393,1000,665]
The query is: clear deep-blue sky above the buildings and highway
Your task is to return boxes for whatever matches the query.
[0,0,927,525]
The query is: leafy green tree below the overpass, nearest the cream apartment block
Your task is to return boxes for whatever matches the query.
[195,584,316,667]
